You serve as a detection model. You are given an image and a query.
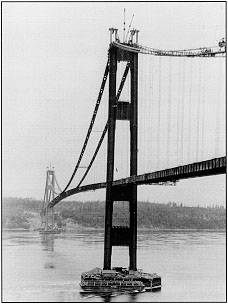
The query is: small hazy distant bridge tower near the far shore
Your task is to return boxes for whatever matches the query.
[41,168,55,231]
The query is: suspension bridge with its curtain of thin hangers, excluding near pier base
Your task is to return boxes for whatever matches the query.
[42,28,226,270]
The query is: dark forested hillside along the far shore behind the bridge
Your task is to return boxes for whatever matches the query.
[2,198,226,229]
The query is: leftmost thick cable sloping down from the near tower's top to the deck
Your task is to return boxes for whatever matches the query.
[62,59,109,193]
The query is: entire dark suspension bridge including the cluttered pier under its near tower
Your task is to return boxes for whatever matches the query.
[44,28,226,291]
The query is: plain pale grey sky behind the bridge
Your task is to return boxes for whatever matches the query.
[2,2,226,206]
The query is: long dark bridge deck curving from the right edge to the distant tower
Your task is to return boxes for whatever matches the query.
[48,156,226,207]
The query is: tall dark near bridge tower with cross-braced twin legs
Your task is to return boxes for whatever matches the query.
[104,30,138,270]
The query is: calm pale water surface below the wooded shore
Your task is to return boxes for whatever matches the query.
[2,230,226,302]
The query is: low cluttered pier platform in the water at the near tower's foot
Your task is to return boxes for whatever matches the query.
[80,267,161,292]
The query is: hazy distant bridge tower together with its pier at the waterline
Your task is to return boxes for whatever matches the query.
[39,167,61,234]
